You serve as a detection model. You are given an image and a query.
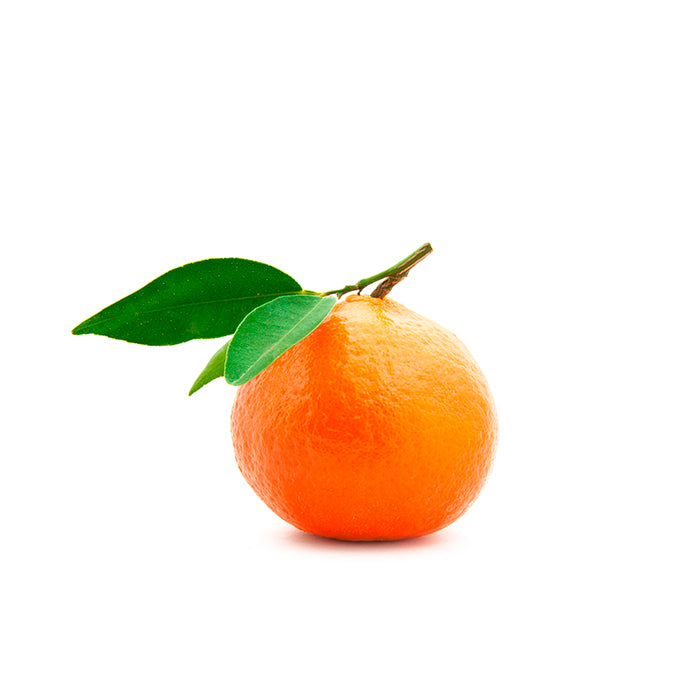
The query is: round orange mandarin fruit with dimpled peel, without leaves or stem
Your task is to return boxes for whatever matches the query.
[231,295,497,540]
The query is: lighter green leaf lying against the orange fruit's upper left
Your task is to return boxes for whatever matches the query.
[224,295,335,386]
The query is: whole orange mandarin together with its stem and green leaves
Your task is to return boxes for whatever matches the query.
[73,243,497,541]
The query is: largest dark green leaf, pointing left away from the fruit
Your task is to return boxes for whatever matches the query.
[73,258,301,345]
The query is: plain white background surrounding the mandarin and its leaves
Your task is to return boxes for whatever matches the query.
[0,0,700,700]
